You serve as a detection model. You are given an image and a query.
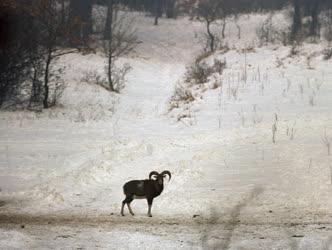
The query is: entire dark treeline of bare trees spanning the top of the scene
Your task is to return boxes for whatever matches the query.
[0,0,332,108]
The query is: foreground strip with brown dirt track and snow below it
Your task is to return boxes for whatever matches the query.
[0,214,332,250]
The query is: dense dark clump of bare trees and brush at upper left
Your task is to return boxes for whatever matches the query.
[0,0,89,108]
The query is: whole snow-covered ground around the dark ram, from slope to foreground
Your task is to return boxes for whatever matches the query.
[0,11,332,249]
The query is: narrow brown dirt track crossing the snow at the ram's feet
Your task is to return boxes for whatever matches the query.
[0,213,332,227]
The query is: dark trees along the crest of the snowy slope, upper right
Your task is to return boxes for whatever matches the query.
[189,0,332,51]
